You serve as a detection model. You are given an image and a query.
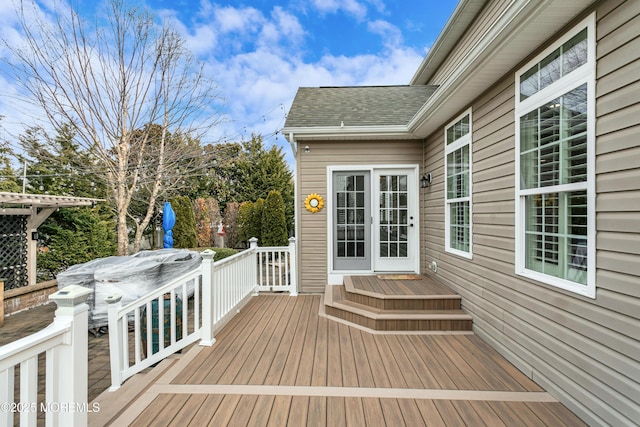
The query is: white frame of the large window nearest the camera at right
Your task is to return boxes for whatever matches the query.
[515,14,596,298]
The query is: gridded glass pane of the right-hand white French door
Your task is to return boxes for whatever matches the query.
[378,175,409,258]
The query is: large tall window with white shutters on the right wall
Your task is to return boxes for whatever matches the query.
[516,16,595,298]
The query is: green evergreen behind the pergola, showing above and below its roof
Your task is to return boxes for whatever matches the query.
[13,126,116,280]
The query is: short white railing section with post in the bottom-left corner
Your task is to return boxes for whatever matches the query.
[0,285,91,426]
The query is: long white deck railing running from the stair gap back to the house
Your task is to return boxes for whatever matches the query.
[108,238,297,391]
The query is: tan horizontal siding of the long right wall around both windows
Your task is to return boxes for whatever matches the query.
[421,0,640,425]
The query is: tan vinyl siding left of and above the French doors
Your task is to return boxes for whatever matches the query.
[297,141,422,292]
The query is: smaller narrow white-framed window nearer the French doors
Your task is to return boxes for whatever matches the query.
[444,111,472,258]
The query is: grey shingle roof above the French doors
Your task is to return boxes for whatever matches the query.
[285,86,437,128]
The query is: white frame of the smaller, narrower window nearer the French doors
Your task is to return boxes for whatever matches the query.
[444,108,473,259]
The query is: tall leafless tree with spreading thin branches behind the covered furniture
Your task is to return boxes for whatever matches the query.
[7,0,219,255]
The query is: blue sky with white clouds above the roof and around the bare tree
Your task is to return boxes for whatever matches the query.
[0,0,457,157]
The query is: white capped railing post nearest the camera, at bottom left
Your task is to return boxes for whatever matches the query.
[47,285,93,426]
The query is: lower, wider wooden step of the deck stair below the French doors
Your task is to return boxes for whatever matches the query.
[325,285,473,332]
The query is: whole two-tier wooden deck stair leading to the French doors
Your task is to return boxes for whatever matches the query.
[324,275,473,333]
